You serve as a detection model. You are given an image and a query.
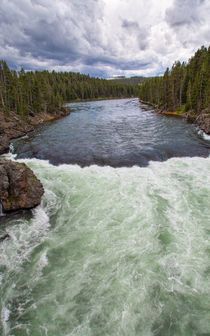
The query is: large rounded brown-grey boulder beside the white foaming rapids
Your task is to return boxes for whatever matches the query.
[0,159,44,212]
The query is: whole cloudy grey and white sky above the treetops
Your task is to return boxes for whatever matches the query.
[0,0,210,78]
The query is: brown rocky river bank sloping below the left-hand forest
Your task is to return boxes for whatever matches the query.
[0,107,70,155]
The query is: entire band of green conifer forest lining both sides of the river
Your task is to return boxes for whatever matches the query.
[0,47,210,131]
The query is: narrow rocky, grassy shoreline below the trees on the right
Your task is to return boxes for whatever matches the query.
[139,99,210,135]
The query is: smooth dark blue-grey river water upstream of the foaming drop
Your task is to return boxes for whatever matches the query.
[12,99,210,167]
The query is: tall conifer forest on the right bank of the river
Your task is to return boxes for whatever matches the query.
[139,46,210,116]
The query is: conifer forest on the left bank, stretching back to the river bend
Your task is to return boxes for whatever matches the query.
[0,61,138,116]
